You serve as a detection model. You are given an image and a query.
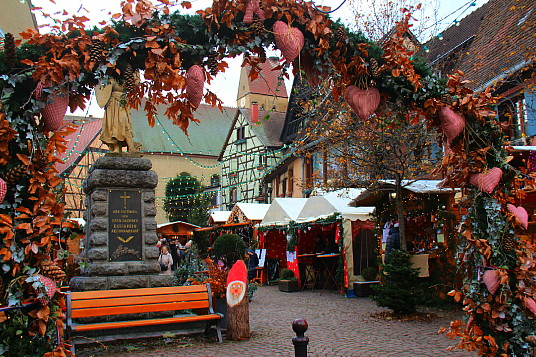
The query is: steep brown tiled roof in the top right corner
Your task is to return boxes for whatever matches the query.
[459,0,536,89]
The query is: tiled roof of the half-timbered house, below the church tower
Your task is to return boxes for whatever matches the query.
[239,108,285,147]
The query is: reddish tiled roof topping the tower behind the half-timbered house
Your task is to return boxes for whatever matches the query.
[246,58,288,98]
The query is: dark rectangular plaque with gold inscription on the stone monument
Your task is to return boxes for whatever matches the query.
[108,190,142,261]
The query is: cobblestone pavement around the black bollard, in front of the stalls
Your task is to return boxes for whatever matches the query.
[80,286,475,357]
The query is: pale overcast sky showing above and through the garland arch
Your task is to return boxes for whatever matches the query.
[32,0,487,116]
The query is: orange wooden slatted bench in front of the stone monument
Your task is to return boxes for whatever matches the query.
[66,284,223,353]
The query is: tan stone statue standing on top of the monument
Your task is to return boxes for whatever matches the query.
[95,79,140,154]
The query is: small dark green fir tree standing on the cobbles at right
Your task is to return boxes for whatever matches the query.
[372,250,422,314]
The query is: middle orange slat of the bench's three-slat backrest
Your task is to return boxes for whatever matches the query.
[72,292,208,310]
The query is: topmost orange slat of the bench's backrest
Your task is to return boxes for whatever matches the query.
[70,284,207,300]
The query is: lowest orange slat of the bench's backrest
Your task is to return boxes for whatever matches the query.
[71,300,209,318]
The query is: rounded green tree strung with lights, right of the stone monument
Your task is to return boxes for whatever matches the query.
[164,172,210,226]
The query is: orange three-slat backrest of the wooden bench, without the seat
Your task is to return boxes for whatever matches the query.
[67,284,213,319]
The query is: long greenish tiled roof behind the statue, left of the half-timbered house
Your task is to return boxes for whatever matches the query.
[132,104,236,156]
